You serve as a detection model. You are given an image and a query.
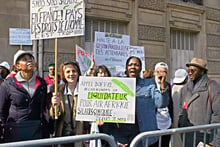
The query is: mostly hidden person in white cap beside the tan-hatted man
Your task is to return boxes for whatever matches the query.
[172,69,188,147]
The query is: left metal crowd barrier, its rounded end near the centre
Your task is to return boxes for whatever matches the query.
[0,133,117,147]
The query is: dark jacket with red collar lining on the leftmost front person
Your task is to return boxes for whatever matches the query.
[0,75,47,142]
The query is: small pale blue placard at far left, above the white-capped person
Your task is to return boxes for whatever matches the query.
[9,28,32,45]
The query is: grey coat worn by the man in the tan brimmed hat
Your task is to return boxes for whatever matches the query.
[179,74,220,146]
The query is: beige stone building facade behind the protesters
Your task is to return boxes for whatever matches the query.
[0,0,220,81]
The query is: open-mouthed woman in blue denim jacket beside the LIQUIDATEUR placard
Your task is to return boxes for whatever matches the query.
[108,56,169,147]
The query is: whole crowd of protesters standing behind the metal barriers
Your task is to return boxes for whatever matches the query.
[0,46,220,147]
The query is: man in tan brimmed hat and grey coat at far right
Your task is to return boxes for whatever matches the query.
[178,58,220,147]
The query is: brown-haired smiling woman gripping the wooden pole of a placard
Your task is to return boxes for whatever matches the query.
[50,61,87,146]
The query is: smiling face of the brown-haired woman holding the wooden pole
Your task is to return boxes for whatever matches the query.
[63,64,79,83]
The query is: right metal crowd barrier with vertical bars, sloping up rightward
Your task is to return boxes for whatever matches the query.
[130,123,220,147]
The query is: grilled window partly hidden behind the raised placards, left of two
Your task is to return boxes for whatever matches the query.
[85,18,127,54]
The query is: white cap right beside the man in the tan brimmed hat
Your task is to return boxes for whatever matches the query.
[173,69,188,84]
